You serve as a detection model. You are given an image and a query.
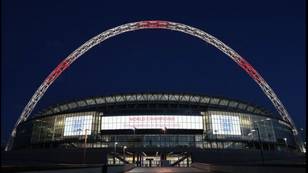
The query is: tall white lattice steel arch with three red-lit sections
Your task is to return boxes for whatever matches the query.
[5,20,298,150]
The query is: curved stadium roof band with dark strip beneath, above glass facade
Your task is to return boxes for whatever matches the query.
[34,93,281,119]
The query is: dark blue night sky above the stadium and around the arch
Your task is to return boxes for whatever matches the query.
[1,0,306,142]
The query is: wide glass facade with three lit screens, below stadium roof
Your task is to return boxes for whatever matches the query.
[14,110,296,150]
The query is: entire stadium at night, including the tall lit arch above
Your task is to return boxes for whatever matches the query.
[5,20,305,167]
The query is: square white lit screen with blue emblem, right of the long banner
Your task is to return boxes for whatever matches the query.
[211,115,241,135]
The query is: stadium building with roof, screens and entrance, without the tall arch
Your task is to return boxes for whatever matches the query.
[13,93,300,166]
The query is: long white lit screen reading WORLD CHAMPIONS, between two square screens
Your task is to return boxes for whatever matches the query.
[101,115,203,130]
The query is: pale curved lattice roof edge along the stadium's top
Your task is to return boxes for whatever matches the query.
[34,92,272,116]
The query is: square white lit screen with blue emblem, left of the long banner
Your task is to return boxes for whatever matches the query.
[64,115,92,136]
